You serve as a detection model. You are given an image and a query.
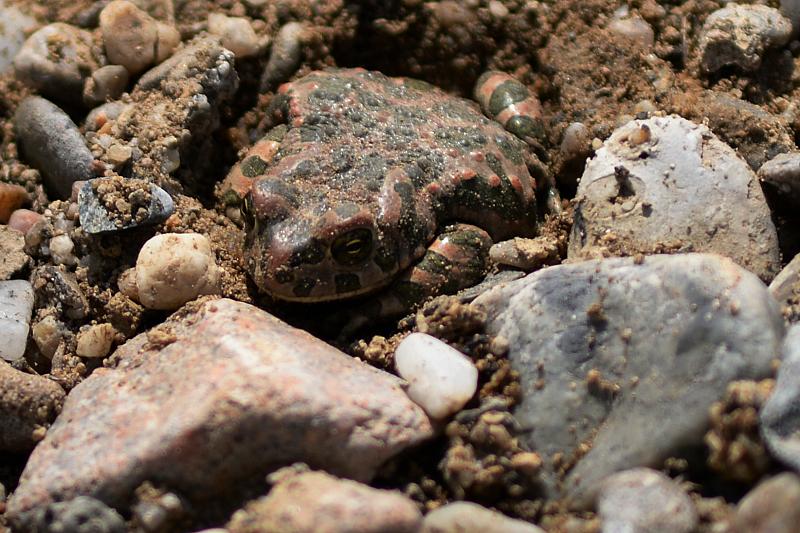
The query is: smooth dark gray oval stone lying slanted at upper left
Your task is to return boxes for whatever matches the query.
[14,96,94,199]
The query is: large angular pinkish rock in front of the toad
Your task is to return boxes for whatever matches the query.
[8,299,433,522]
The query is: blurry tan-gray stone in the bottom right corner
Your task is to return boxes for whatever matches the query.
[734,472,800,533]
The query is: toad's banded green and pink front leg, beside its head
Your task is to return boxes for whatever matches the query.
[340,224,492,339]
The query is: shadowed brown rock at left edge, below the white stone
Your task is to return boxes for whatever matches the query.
[0,360,65,452]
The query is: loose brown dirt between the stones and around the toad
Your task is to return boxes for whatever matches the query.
[0,0,800,532]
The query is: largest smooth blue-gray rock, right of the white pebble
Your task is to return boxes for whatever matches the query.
[475,254,783,507]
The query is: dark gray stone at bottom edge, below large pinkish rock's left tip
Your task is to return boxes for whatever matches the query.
[18,496,128,533]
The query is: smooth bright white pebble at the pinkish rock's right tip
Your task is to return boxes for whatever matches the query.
[394,333,478,419]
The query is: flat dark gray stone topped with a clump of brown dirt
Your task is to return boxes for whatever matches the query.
[78,177,175,235]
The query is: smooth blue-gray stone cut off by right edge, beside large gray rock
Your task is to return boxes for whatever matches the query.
[761,325,800,471]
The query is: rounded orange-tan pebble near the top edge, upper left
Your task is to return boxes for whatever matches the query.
[100,0,158,74]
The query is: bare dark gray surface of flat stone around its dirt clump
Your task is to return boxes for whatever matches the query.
[78,178,175,234]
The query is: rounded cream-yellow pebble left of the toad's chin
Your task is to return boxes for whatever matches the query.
[136,233,220,309]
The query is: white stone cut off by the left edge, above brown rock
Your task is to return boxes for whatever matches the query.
[0,279,33,361]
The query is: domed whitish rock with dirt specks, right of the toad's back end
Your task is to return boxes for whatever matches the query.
[568,115,780,280]
